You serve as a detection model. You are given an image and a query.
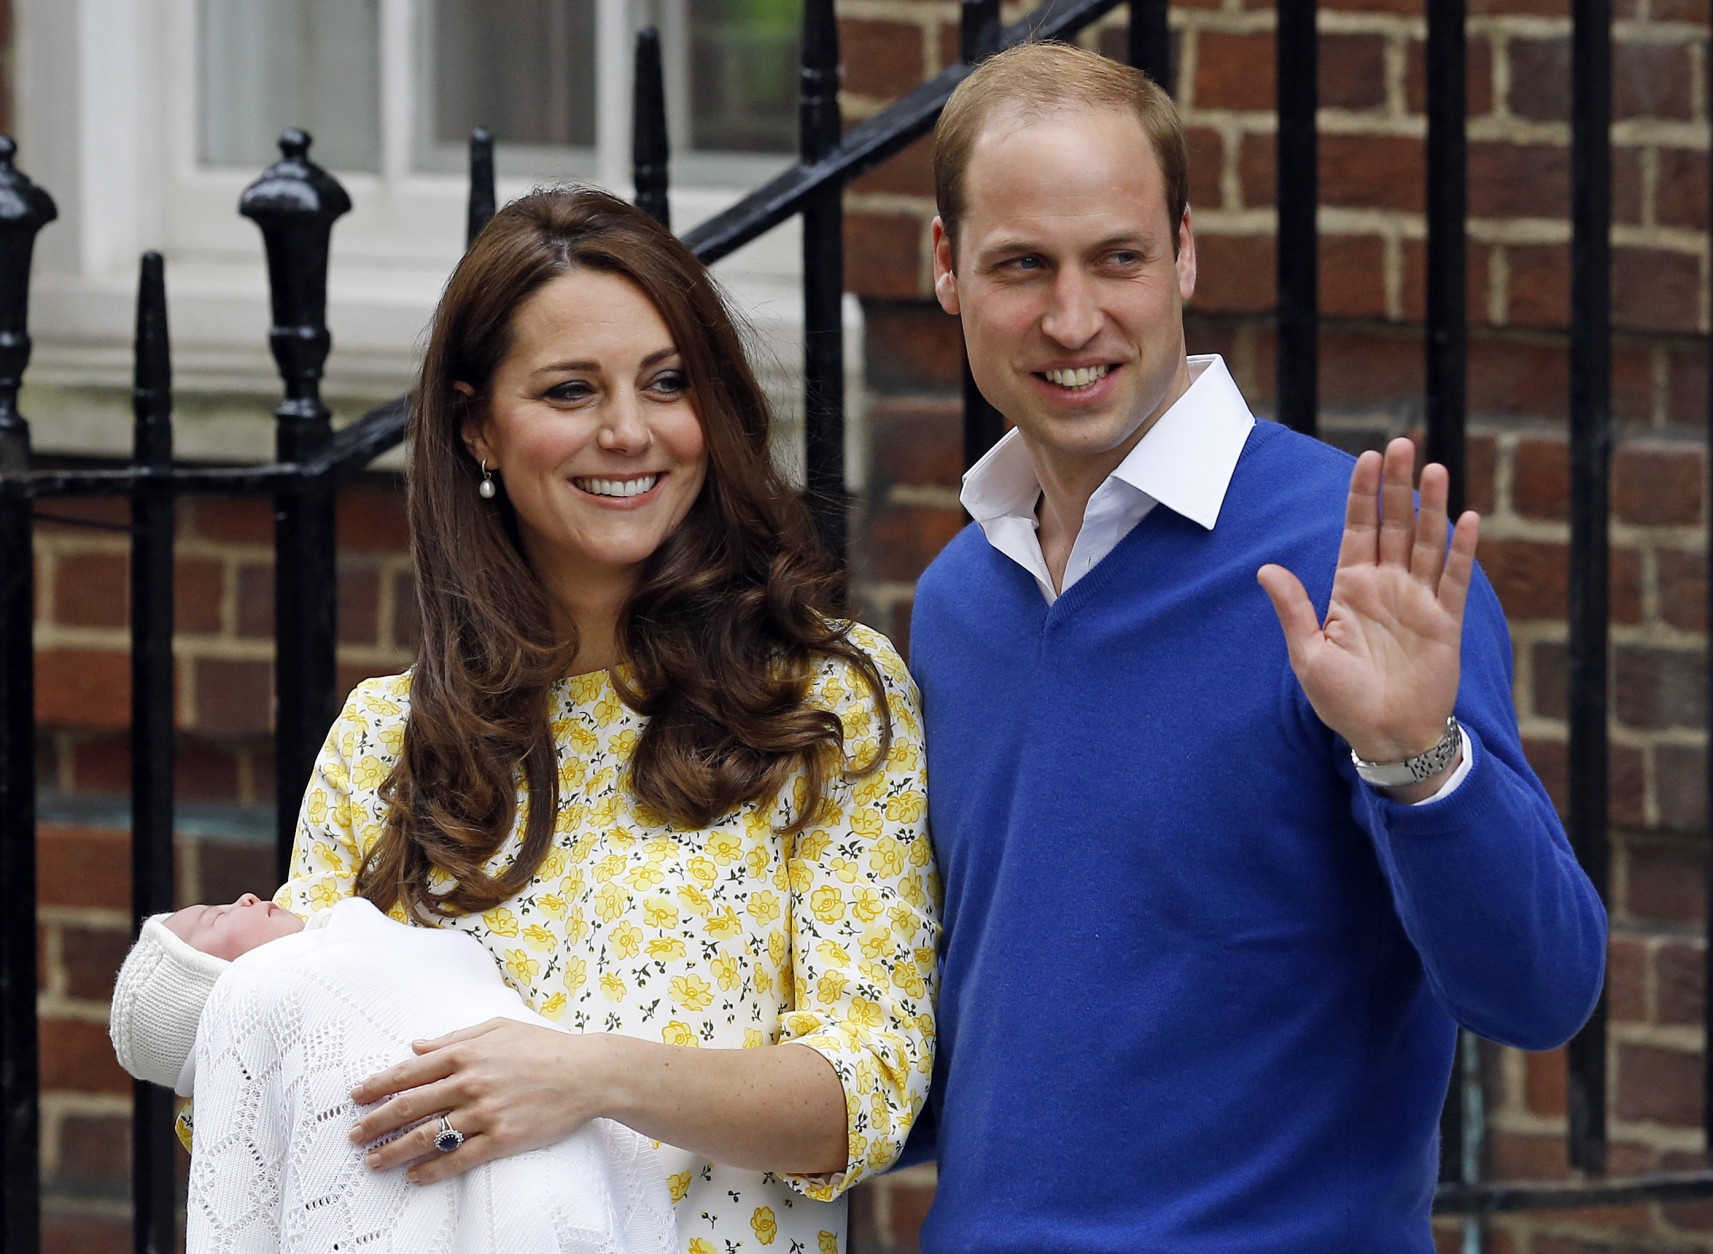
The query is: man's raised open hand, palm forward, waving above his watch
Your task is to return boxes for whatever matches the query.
[1257,439,1480,762]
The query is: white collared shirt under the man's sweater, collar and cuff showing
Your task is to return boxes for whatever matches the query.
[959,353,1473,805]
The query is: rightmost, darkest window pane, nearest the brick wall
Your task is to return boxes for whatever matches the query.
[685,0,802,152]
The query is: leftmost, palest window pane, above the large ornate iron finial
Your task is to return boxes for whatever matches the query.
[199,0,380,170]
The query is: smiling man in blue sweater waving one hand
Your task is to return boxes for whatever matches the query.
[911,45,1605,1254]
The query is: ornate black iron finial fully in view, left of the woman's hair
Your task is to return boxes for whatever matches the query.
[238,128,351,438]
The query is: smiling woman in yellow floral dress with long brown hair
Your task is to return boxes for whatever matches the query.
[276,190,939,1254]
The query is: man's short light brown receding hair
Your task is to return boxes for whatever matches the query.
[934,43,1189,262]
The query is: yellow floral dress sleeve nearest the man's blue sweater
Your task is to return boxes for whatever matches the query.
[779,627,940,1201]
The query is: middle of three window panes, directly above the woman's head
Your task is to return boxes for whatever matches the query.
[428,0,594,147]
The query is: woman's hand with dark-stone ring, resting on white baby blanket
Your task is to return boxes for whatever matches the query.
[351,1019,613,1184]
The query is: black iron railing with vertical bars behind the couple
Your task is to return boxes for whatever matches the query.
[0,0,1713,1254]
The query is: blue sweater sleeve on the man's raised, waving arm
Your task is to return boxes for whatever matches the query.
[1341,570,1607,1050]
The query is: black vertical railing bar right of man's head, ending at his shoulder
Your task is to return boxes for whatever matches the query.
[1274,0,1321,435]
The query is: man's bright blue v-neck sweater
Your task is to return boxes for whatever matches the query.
[911,421,1605,1254]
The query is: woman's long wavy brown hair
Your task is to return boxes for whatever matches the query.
[356,188,891,922]
